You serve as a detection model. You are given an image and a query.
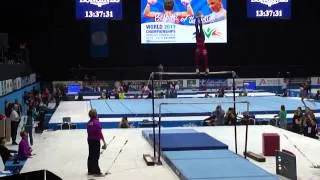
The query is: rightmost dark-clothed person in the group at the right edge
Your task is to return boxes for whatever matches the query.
[303,108,317,138]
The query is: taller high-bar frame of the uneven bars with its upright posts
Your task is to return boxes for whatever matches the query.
[149,71,238,164]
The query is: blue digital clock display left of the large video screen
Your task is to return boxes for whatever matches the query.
[76,0,122,20]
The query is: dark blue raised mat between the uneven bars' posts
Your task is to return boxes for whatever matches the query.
[149,133,228,151]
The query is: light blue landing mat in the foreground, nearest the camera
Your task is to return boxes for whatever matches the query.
[163,150,278,180]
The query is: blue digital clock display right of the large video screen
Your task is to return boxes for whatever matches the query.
[247,0,291,19]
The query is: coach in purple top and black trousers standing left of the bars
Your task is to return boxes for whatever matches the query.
[87,109,107,176]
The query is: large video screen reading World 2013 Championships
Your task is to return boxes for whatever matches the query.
[141,0,227,44]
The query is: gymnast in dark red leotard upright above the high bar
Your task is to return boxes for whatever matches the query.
[195,13,209,73]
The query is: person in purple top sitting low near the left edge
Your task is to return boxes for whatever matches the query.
[18,131,34,161]
